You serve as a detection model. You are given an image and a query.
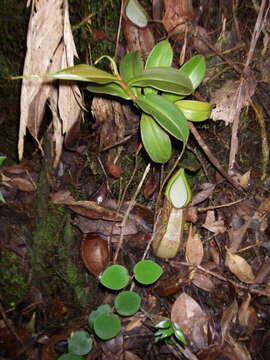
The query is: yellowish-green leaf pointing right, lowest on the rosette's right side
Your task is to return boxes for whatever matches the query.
[175,100,212,121]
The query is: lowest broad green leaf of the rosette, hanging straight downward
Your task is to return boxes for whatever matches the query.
[140,113,172,164]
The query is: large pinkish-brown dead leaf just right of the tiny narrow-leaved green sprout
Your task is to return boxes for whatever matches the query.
[171,293,208,349]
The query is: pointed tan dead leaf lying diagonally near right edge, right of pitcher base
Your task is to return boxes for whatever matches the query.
[226,248,255,284]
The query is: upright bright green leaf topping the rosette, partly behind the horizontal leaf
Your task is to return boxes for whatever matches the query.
[144,40,173,94]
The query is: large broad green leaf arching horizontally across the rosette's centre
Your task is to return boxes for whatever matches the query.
[128,67,193,95]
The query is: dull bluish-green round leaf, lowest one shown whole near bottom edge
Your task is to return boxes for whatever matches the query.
[68,330,93,355]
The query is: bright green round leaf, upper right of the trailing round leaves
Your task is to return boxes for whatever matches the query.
[133,260,163,285]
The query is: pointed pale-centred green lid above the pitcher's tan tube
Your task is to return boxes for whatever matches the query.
[165,169,192,209]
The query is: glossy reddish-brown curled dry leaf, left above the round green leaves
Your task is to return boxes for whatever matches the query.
[81,233,109,276]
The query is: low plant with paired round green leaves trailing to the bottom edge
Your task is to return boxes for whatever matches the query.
[58,260,163,360]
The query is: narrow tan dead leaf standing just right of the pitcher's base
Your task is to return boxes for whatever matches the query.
[186,226,204,265]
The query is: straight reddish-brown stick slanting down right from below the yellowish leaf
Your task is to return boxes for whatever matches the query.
[188,121,244,191]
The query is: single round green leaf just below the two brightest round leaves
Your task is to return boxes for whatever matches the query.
[114,291,141,316]
